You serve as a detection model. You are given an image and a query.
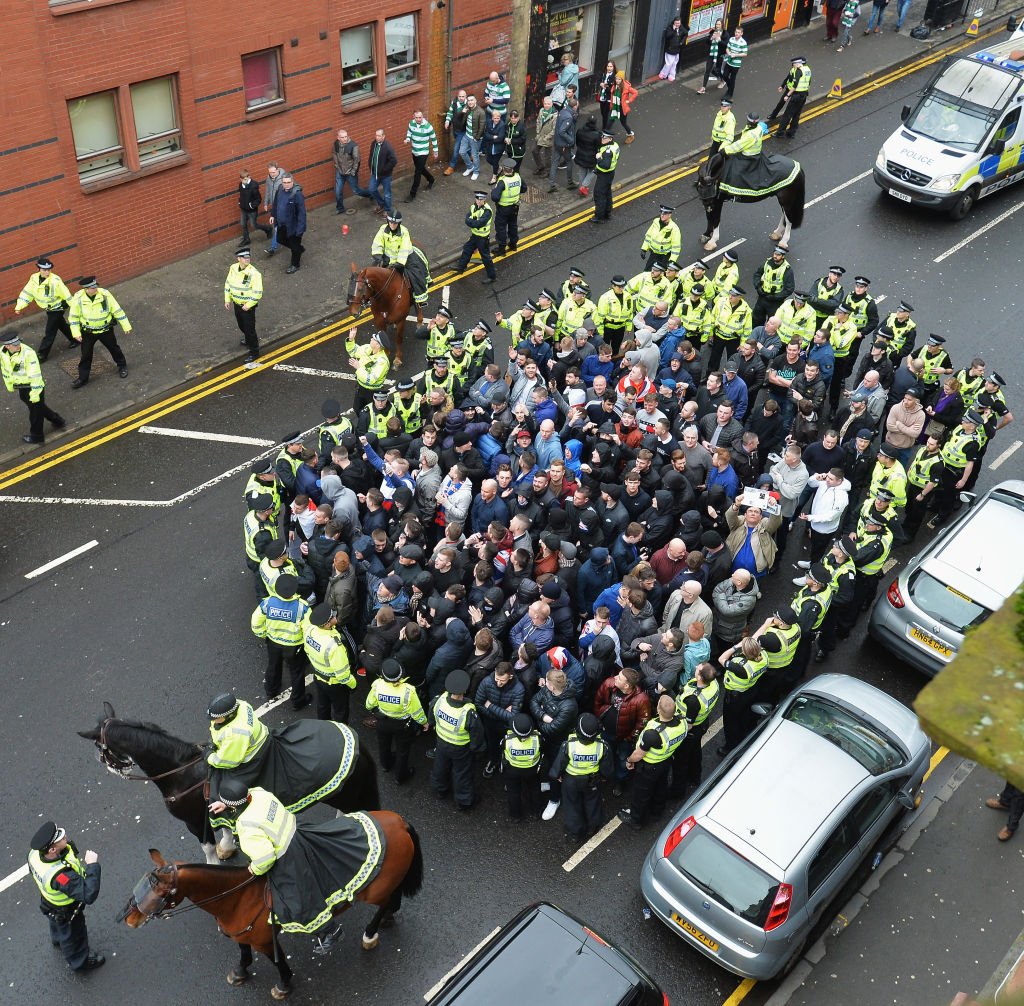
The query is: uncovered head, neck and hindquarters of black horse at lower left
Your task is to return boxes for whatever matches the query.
[79,702,380,863]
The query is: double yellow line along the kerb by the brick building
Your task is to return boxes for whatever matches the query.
[0,29,1002,495]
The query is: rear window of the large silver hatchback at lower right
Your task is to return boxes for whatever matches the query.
[673,827,778,926]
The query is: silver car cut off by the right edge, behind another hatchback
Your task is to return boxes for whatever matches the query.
[868,480,1024,677]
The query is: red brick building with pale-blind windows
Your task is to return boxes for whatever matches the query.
[0,0,512,317]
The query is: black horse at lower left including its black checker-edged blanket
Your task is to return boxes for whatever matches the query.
[79,702,381,864]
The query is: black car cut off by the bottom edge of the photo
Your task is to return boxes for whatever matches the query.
[427,902,669,1006]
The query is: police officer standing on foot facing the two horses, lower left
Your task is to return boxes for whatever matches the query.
[29,821,106,971]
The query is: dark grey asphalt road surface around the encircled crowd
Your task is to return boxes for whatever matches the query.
[0,60,1024,1006]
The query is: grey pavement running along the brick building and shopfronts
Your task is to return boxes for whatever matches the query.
[0,0,1010,463]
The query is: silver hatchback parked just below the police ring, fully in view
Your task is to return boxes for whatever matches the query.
[640,674,930,980]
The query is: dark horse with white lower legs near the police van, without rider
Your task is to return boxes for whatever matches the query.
[695,151,806,251]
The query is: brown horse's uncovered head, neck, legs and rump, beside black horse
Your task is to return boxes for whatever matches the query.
[118,810,423,1000]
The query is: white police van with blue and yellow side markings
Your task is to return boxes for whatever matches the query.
[873,20,1024,220]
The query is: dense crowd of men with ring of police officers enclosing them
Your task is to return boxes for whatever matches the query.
[244,224,1013,839]
